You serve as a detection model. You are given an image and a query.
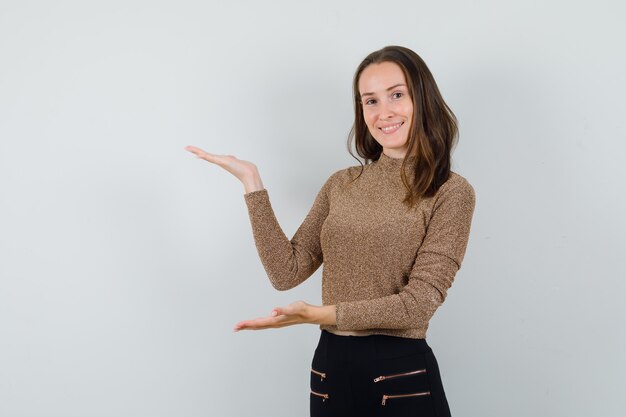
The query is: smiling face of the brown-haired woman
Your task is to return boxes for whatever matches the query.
[359,62,413,158]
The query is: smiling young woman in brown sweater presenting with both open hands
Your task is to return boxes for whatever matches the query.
[186,46,475,417]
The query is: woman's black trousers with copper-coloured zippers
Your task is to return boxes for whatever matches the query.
[310,330,450,417]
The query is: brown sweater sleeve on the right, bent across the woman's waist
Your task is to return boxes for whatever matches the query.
[336,181,475,330]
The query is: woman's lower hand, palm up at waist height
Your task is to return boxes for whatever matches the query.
[234,301,337,332]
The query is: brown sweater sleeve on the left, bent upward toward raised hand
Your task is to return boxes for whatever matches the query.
[244,171,333,291]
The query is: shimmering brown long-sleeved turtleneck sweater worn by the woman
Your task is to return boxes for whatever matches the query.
[244,153,475,339]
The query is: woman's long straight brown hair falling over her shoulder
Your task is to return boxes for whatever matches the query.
[348,45,458,207]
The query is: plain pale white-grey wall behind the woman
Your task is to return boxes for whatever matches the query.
[0,0,626,417]
